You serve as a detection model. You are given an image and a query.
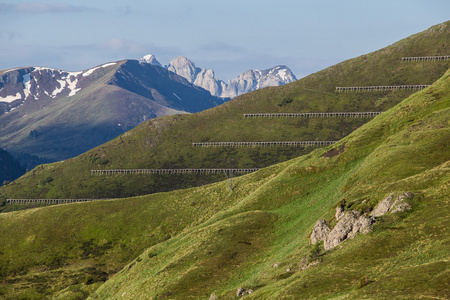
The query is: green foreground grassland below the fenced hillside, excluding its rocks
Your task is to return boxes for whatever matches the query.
[0,58,450,299]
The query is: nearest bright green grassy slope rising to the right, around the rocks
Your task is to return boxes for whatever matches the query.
[92,68,450,299]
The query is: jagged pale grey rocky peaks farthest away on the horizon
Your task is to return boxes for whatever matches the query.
[165,56,297,98]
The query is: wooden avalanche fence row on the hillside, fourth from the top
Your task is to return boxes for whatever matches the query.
[192,141,337,148]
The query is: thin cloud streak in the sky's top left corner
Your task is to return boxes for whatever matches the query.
[0,2,98,14]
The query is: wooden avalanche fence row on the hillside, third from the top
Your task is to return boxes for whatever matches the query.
[244,111,382,119]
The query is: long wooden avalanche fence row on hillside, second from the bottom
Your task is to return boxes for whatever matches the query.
[91,168,259,175]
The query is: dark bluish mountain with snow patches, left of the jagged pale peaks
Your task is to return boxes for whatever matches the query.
[0,56,225,161]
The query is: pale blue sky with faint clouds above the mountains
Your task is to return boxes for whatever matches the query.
[0,0,450,81]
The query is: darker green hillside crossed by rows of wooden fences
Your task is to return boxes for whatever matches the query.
[0,22,450,202]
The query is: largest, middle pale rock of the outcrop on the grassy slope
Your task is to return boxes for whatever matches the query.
[324,210,374,250]
